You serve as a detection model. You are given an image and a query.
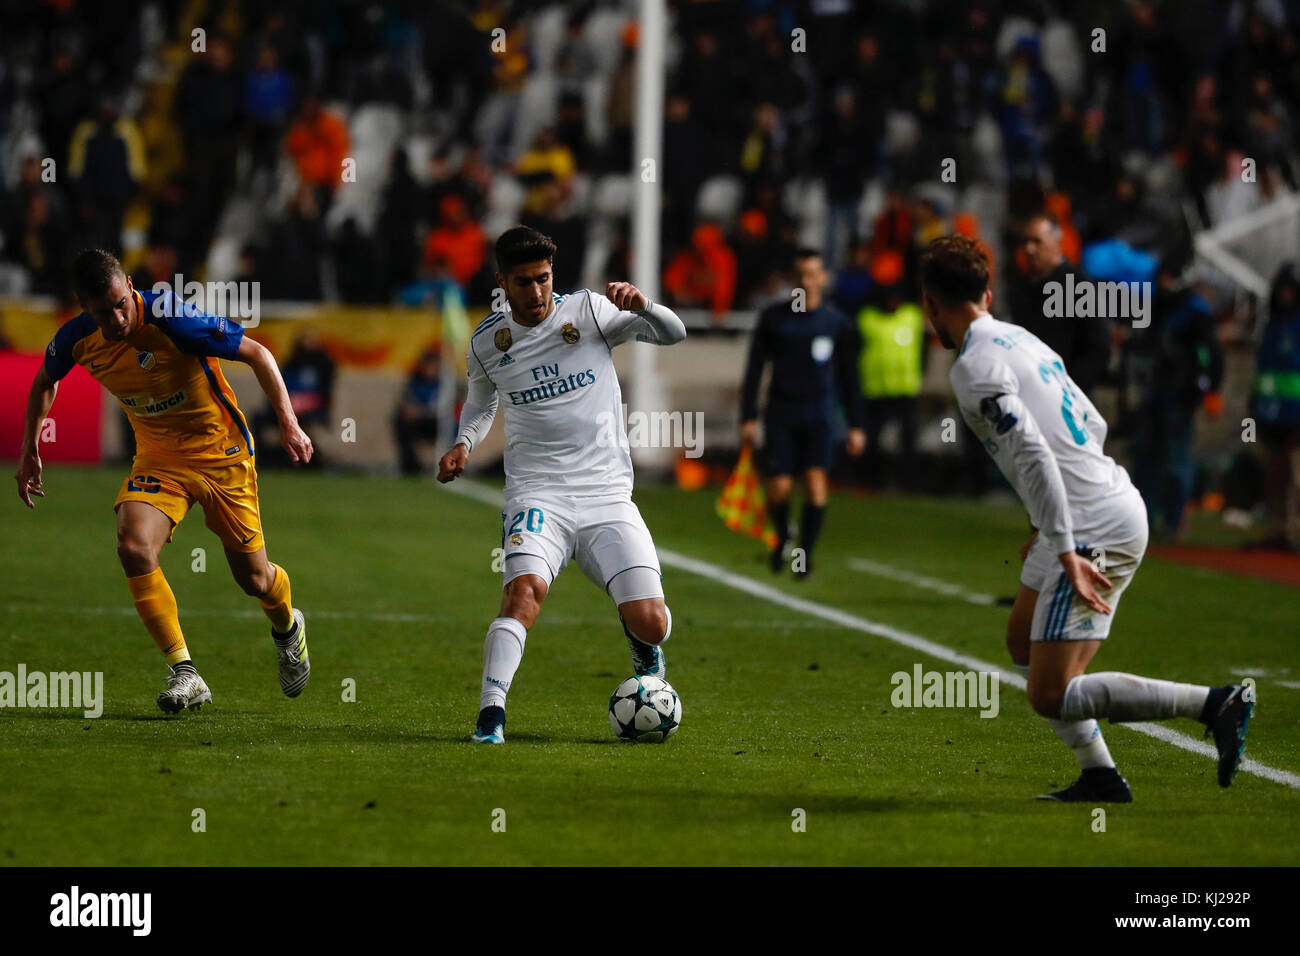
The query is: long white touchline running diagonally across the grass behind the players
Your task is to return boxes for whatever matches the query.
[446,481,1300,790]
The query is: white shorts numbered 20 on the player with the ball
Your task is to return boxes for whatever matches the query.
[501,494,663,601]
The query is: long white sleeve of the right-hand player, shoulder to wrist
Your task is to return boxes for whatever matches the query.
[952,365,1075,554]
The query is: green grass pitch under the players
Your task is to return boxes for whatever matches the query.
[0,467,1300,866]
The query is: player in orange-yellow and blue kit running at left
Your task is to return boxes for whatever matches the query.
[16,250,312,713]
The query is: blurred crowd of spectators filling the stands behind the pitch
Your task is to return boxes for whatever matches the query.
[0,0,1300,546]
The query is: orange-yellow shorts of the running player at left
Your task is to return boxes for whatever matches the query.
[113,457,263,554]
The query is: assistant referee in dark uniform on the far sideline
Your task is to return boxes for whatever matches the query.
[740,248,866,578]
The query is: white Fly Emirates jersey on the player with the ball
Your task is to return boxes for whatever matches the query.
[458,289,657,499]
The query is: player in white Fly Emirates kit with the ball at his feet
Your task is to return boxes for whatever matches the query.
[438,226,686,744]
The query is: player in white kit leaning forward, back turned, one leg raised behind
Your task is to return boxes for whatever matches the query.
[920,235,1255,803]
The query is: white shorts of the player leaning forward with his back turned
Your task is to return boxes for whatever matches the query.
[1021,524,1147,641]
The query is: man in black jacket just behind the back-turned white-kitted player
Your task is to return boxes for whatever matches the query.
[995,213,1110,398]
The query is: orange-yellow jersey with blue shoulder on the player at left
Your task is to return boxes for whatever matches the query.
[46,290,254,466]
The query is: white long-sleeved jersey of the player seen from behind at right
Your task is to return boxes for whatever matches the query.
[949,316,1145,554]
